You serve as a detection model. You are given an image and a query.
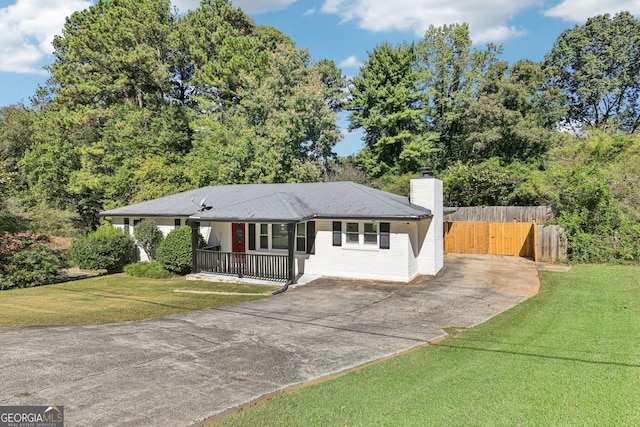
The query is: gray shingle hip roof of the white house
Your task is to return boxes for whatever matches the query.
[100,182,431,222]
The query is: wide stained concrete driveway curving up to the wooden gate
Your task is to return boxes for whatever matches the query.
[0,255,539,426]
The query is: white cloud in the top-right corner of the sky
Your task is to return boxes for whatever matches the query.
[544,0,640,24]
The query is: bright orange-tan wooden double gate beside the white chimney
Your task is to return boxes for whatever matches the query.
[444,221,538,259]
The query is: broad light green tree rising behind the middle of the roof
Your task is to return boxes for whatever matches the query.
[186,31,338,185]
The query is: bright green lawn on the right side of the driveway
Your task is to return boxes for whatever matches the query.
[214,266,640,426]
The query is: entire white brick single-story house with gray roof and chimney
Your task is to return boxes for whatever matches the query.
[100,174,444,283]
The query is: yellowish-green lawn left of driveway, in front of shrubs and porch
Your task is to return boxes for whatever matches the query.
[0,274,277,326]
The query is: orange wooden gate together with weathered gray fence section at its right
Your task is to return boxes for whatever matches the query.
[444,221,567,262]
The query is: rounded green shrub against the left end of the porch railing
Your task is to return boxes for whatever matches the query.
[156,226,205,274]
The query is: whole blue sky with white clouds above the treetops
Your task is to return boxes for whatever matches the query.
[0,0,640,155]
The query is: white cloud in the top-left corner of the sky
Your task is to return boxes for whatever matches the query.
[0,0,92,73]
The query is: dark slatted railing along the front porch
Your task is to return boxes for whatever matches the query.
[196,248,289,281]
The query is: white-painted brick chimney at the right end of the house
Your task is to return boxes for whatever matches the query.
[410,170,444,276]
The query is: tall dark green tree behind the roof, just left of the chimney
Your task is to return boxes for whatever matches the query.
[347,43,430,178]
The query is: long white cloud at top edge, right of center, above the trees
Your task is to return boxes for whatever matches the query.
[322,0,543,43]
